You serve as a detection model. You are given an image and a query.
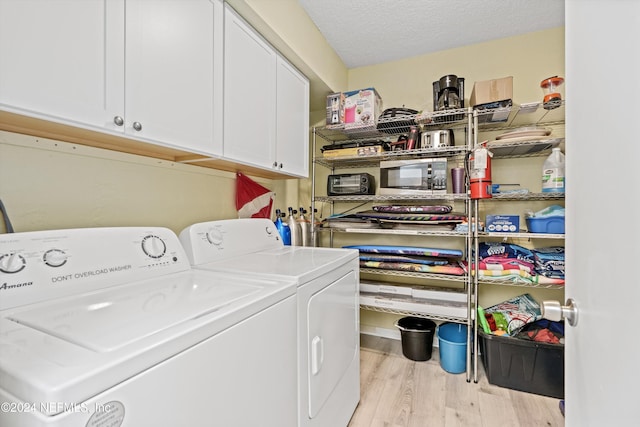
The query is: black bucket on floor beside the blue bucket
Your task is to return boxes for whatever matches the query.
[396,317,436,362]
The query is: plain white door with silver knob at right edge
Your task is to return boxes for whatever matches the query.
[564,0,640,427]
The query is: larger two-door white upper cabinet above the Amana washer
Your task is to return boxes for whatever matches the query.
[0,0,223,155]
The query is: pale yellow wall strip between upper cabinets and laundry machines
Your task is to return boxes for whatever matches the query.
[0,131,292,233]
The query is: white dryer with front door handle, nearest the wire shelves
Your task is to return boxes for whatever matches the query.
[180,219,360,427]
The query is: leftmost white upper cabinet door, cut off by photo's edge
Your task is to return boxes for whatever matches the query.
[0,0,124,130]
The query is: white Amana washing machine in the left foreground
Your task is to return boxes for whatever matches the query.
[0,227,298,427]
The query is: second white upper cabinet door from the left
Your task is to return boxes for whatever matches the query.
[125,0,223,154]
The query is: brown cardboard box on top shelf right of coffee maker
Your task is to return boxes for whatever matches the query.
[469,76,513,123]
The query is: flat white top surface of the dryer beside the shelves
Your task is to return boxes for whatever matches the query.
[195,246,358,285]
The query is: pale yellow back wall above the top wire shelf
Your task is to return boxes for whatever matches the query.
[348,27,564,111]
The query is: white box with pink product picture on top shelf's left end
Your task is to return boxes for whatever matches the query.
[343,87,382,131]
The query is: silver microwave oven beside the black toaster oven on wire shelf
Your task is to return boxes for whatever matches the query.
[379,158,447,195]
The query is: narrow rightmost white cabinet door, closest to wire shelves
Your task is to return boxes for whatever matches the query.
[276,57,309,178]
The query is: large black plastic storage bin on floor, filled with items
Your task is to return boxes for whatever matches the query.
[478,331,564,399]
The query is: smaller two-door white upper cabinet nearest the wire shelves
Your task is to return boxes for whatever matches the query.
[223,6,309,177]
